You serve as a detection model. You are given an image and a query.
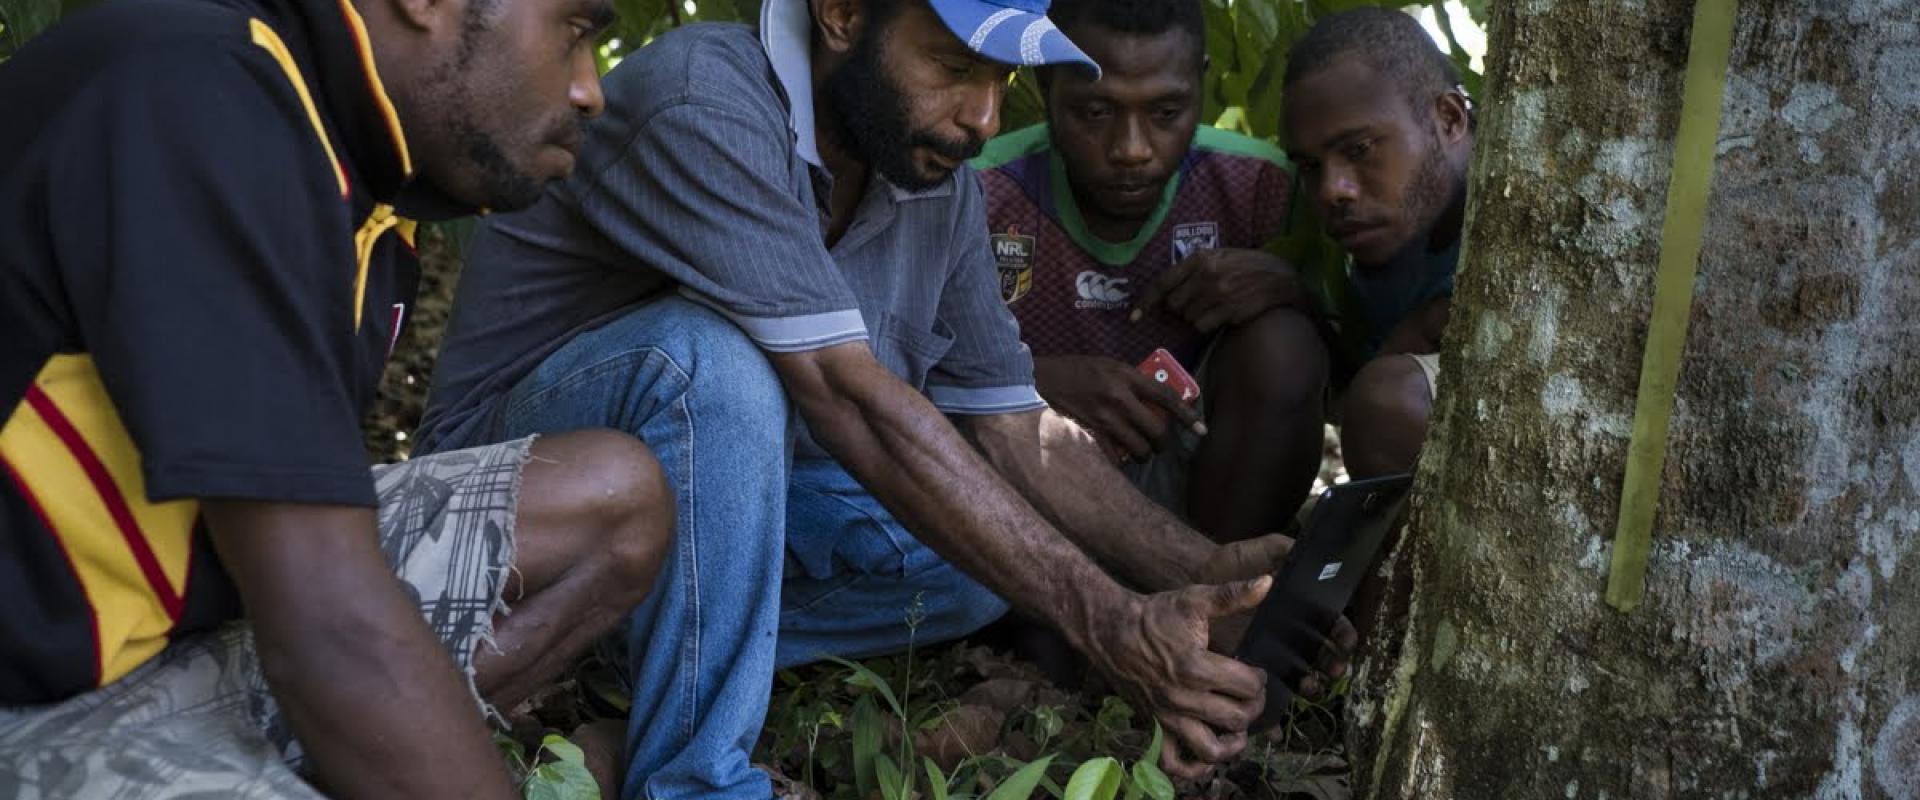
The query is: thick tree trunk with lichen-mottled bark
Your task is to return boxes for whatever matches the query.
[1350,0,1920,798]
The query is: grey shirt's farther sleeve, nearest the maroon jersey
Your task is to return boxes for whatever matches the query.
[927,173,1046,416]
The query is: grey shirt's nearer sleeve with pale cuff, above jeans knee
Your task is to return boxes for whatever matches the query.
[576,98,868,353]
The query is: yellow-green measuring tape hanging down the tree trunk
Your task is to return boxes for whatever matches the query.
[1607,0,1740,612]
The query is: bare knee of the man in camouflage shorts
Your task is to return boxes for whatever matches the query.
[541,430,676,590]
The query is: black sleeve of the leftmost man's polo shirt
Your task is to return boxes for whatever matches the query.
[44,42,374,506]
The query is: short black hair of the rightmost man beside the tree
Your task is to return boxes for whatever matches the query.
[1284,8,1461,107]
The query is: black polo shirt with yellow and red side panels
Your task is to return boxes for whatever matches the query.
[0,0,439,706]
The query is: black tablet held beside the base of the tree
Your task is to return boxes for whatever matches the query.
[1235,476,1413,729]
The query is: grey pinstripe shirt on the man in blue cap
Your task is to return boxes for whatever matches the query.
[417,20,1044,455]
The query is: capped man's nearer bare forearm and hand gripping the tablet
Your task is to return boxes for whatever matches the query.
[772,341,1269,775]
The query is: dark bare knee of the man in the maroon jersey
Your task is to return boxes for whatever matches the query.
[1208,307,1327,409]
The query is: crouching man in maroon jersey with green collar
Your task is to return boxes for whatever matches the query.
[975,0,1327,541]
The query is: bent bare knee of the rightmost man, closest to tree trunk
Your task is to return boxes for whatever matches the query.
[1340,355,1432,478]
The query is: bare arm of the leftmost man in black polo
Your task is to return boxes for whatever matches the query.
[204,501,515,798]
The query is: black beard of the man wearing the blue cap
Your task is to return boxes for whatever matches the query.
[822,25,985,192]
